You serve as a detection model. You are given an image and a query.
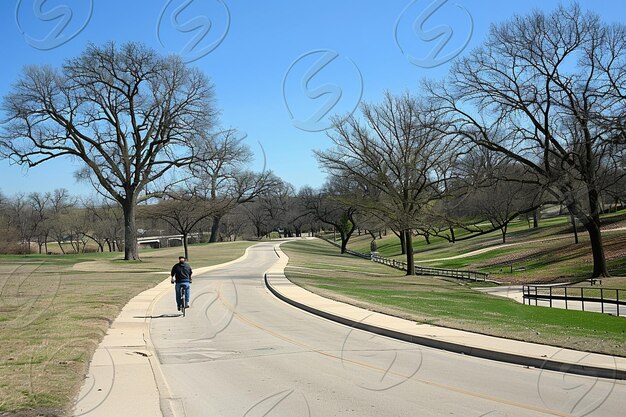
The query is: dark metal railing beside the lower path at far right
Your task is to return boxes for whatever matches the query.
[522,285,626,316]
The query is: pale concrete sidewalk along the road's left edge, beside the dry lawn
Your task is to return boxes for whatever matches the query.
[74,248,249,417]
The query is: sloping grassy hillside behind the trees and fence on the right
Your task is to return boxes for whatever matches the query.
[336,210,626,283]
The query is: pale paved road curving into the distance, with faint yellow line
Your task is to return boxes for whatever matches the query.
[150,242,626,417]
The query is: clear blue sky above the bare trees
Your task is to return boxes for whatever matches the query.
[0,0,626,195]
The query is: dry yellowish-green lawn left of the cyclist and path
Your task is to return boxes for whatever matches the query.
[0,242,254,416]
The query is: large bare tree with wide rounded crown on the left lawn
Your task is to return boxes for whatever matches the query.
[0,42,215,259]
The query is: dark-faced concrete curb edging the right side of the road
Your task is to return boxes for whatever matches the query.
[263,240,626,380]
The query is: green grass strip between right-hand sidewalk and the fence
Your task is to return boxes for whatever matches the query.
[282,240,626,356]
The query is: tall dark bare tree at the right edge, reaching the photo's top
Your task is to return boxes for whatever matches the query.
[429,4,626,277]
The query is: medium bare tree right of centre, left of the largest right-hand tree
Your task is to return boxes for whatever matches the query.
[316,93,455,275]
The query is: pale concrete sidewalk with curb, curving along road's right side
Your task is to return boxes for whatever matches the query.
[265,244,626,380]
